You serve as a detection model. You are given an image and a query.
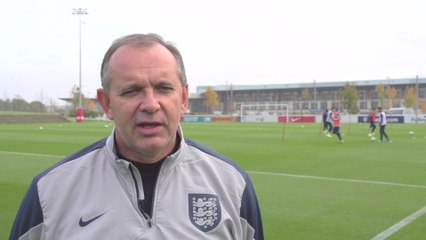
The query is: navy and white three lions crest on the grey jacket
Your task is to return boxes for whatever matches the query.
[188,194,221,232]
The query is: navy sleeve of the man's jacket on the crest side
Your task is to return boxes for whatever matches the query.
[240,175,264,240]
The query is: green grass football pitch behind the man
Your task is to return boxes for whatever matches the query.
[0,122,426,240]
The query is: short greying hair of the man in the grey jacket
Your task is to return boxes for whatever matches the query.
[101,33,187,93]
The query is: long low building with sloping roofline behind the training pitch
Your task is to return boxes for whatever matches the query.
[189,78,426,114]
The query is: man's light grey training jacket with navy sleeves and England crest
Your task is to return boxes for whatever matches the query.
[10,128,263,240]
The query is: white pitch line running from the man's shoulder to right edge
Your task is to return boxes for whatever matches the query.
[247,171,426,189]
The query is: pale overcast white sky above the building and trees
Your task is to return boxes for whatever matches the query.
[0,0,426,104]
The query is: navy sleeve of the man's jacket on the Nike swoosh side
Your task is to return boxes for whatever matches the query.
[9,179,43,240]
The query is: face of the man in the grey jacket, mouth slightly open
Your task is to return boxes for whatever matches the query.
[98,45,188,163]
